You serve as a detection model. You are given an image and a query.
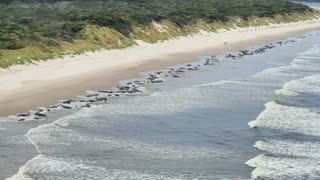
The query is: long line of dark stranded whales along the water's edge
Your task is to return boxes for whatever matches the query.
[9,36,305,121]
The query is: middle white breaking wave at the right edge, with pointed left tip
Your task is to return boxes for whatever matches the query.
[249,101,320,136]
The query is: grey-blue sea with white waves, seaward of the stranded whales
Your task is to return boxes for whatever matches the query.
[0,32,320,180]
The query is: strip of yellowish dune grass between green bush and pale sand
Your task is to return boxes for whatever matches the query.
[0,11,320,68]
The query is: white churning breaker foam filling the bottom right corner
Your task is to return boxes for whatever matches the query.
[250,139,320,180]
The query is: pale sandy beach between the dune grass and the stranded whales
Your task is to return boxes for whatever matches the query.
[0,19,320,116]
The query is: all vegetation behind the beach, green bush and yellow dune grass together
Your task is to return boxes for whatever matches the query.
[0,0,318,68]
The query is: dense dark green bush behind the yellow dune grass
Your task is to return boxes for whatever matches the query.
[0,0,311,49]
